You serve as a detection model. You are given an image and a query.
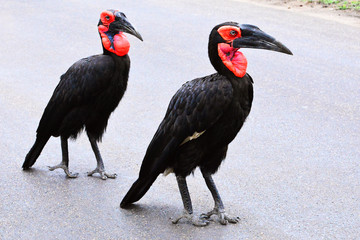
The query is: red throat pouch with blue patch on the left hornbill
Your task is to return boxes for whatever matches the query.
[98,25,130,56]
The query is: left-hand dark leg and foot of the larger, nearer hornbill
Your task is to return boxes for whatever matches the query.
[172,176,209,227]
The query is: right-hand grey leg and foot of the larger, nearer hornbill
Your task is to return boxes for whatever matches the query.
[200,170,239,225]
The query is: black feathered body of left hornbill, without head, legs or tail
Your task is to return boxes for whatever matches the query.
[37,53,130,140]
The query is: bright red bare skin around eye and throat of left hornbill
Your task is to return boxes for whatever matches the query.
[98,11,130,56]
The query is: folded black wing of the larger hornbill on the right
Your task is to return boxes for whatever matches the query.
[139,74,233,178]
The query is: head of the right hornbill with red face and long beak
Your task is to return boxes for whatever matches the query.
[209,22,292,77]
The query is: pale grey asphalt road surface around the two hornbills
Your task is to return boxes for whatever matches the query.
[0,0,360,240]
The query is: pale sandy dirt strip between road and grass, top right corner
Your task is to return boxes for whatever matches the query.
[238,0,360,27]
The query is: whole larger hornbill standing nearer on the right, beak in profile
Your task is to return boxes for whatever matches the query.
[120,22,292,226]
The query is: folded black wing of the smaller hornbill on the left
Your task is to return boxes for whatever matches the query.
[37,55,115,136]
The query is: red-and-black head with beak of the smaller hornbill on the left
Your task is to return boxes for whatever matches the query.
[98,9,143,56]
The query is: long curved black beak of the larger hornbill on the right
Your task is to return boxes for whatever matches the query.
[233,24,293,55]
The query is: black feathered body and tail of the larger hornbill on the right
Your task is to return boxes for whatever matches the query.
[121,73,253,207]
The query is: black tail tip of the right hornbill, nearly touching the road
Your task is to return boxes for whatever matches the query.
[120,175,157,208]
